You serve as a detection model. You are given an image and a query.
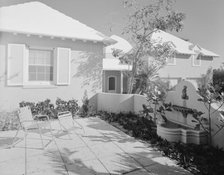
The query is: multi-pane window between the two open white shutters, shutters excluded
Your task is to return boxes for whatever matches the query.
[28,49,54,82]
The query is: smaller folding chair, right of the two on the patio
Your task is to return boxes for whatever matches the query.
[58,111,85,139]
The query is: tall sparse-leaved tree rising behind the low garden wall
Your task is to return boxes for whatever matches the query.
[116,0,185,93]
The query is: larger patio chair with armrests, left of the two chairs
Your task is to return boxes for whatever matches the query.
[11,106,54,149]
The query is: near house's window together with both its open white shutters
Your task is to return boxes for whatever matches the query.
[7,43,71,88]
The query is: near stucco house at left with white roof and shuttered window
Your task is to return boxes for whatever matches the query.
[0,2,115,110]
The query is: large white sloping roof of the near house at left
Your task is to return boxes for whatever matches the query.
[0,2,115,44]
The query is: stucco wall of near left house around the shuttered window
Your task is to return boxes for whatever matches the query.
[0,33,104,111]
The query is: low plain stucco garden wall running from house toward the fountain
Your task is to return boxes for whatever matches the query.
[89,93,147,113]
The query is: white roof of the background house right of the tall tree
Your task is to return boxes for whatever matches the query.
[152,30,219,57]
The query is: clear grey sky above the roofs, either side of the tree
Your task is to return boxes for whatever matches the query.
[0,0,224,61]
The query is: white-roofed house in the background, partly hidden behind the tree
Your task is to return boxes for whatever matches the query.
[103,31,222,93]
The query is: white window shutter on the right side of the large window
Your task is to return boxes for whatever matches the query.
[54,47,71,85]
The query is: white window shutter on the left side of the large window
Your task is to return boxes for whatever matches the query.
[7,44,27,86]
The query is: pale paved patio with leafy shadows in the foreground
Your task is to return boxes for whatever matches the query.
[0,118,190,175]
